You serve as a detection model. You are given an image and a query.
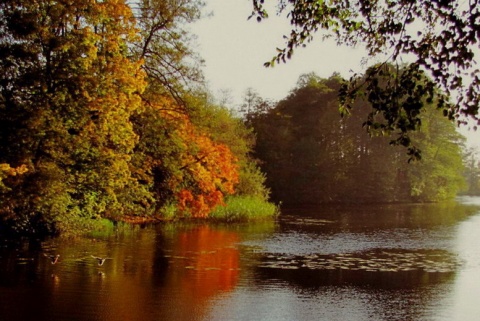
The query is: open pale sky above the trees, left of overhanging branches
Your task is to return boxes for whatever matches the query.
[192,0,480,150]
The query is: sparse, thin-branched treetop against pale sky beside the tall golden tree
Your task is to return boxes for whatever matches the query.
[131,0,204,105]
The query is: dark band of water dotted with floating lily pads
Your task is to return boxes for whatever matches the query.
[258,250,458,289]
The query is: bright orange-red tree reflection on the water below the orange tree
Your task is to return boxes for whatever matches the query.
[147,225,240,320]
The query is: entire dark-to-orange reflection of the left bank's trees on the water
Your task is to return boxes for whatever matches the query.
[0,225,240,321]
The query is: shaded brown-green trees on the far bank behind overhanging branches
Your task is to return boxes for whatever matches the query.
[247,69,464,204]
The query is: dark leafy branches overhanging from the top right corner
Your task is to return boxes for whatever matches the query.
[252,0,480,157]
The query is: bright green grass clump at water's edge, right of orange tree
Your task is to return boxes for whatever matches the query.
[209,196,279,222]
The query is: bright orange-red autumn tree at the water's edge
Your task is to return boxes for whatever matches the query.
[134,96,239,218]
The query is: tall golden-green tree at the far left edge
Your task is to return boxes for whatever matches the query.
[0,0,146,235]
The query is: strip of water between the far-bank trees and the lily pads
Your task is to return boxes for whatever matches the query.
[250,202,478,255]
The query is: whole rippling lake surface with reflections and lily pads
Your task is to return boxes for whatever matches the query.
[0,198,480,321]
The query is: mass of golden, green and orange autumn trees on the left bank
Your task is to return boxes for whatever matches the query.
[0,0,267,233]
